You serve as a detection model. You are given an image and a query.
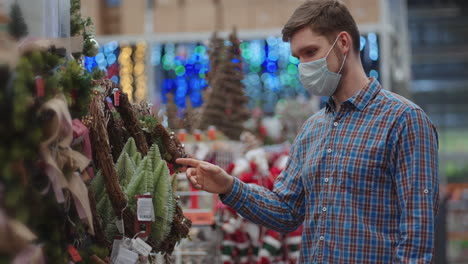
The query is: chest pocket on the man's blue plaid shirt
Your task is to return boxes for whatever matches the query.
[338,147,390,194]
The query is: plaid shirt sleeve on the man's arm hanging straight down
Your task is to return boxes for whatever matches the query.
[393,109,439,263]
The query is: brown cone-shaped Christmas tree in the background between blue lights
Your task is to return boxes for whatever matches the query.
[199,30,250,140]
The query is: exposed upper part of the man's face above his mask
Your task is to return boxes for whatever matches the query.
[290,27,342,72]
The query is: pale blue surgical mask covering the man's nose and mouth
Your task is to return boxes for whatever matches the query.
[299,37,346,96]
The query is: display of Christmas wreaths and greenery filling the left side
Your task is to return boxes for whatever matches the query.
[0,1,191,263]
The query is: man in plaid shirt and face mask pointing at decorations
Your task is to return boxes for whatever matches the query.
[177,0,438,264]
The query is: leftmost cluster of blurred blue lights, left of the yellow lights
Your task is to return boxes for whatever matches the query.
[84,41,120,83]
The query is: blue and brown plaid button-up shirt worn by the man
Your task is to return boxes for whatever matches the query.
[220,79,438,264]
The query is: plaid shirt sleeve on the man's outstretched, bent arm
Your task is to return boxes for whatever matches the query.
[220,135,305,233]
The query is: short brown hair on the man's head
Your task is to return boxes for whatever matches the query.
[281,0,360,53]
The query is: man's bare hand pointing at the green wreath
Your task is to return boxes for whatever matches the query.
[176,159,234,194]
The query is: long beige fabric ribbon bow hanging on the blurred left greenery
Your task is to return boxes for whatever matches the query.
[39,95,94,234]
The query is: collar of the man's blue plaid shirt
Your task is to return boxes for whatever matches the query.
[326,77,382,112]
